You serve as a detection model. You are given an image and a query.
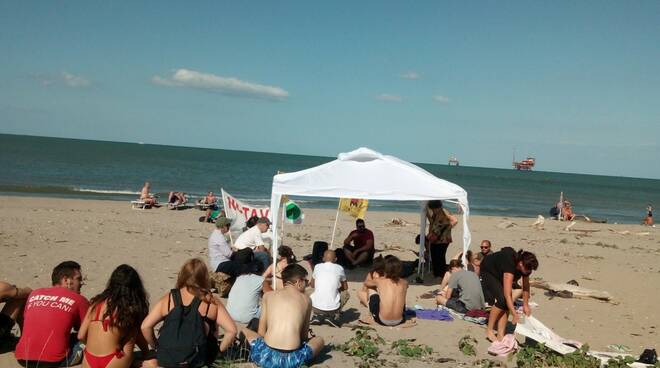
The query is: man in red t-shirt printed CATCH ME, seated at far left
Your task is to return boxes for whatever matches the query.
[15,261,89,367]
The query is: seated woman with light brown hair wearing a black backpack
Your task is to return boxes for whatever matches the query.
[142,258,237,368]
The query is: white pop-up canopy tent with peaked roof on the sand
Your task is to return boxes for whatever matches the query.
[270,147,471,288]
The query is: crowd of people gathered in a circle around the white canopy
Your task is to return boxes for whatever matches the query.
[0,201,538,368]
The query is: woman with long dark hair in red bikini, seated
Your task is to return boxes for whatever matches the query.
[78,264,149,368]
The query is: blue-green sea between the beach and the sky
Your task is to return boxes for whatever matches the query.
[0,134,660,223]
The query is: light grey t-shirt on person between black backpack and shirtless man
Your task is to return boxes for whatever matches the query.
[227,274,264,323]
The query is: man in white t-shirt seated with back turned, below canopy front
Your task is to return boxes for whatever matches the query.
[311,249,348,312]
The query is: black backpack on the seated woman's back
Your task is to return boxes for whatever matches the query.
[156,289,208,368]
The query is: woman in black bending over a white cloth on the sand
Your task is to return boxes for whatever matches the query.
[481,247,539,342]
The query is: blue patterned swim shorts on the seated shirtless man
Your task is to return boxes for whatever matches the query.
[250,337,313,368]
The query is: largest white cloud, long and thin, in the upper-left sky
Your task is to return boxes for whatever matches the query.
[151,69,289,100]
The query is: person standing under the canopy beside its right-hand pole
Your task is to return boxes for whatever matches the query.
[426,200,458,277]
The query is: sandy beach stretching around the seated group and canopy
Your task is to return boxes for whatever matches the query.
[0,197,660,367]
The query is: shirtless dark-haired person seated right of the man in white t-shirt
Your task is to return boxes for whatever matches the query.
[358,257,408,326]
